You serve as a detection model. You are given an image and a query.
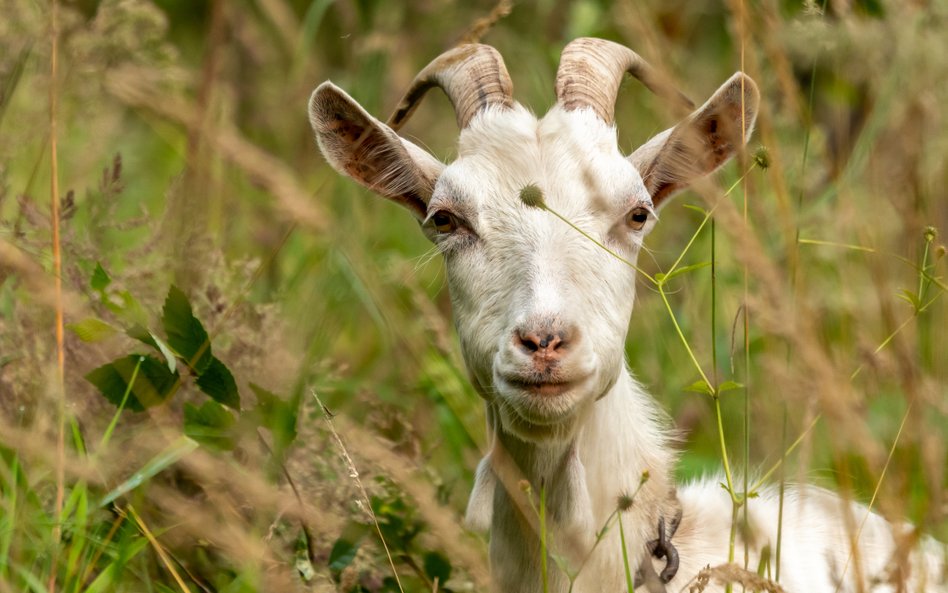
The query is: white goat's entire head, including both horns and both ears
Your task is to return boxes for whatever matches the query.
[310,39,758,441]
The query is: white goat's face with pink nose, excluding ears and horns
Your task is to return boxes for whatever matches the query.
[434,108,654,439]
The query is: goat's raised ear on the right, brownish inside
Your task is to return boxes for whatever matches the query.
[629,72,760,207]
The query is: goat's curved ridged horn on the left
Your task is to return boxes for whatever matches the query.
[388,44,513,130]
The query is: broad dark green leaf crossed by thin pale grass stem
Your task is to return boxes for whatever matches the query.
[86,354,178,412]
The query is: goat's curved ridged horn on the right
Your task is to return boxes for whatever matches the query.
[556,37,694,124]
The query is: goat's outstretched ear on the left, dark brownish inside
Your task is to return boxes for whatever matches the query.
[309,81,444,220]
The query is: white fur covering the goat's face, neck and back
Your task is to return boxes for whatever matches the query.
[313,77,946,593]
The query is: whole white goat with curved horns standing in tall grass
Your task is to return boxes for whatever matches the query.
[309,39,945,593]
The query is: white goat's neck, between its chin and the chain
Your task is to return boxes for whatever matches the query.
[491,371,675,588]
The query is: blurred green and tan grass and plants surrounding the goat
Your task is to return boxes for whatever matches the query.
[0,0,948,593]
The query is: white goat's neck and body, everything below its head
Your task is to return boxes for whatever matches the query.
[491,373,948,593]
